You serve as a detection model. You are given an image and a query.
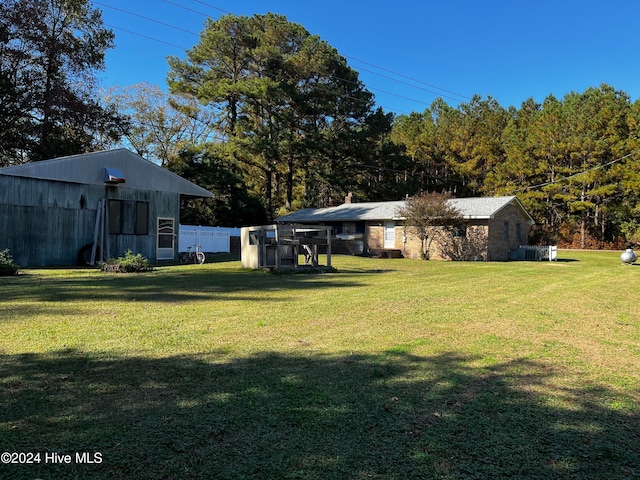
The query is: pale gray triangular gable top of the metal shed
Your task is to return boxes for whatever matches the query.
[0,148,213,198]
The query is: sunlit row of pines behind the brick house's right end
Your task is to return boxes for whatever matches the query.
[392,85,640,248]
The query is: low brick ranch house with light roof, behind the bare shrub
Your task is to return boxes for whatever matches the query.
[276,196,535,261]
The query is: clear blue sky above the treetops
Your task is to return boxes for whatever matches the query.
[94,0,640,114]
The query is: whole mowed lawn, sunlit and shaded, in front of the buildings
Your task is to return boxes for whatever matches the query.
[0,251,640,480]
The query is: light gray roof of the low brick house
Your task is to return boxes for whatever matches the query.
[276,196,535,225]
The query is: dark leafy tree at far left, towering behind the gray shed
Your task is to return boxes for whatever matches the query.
[0,0,121,164]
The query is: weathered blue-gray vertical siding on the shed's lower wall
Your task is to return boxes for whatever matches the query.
[0,175,180,267]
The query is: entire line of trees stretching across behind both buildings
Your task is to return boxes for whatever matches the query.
[0,0,640,247]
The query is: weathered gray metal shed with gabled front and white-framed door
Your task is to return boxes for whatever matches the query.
[0,149,213,267]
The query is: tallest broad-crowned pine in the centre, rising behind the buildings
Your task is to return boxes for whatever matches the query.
[168,14,373,218]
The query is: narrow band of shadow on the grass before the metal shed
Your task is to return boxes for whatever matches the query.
[0,265,364,302]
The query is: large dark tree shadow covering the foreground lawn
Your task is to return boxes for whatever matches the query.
[0,350,640,480]
